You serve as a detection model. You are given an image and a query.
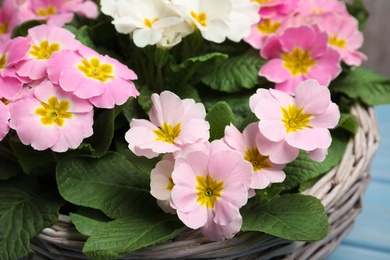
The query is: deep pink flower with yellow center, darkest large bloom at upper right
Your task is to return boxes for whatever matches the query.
[259,25,341,94]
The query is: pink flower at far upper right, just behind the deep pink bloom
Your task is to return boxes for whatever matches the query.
[318,13,367,66]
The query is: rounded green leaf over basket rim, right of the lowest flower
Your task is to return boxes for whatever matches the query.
[241,194,329,241]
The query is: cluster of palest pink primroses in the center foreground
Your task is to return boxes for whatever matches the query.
[125,80,340,240]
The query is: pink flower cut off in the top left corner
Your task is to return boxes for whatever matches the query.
[0,0,20,45]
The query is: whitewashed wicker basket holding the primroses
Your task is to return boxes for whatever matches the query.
[32,107,379,260]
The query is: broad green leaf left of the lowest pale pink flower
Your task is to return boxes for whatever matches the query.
[57,152,157,218]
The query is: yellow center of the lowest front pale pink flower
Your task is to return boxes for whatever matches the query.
[196,174,224,209]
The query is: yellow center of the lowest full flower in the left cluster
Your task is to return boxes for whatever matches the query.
[35,97,73,126]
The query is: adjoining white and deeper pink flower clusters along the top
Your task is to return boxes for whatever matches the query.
[101,0,366,94]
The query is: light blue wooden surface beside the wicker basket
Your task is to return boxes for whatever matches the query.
[327,105,390,260]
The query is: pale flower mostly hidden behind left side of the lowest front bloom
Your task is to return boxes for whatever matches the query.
[150,154,176,214]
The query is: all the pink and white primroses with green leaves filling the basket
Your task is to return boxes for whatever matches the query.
[0,0,390,259]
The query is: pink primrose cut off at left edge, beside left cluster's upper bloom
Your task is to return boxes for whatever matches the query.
[0,37,30,99]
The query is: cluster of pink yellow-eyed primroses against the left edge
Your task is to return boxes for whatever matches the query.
[0,22,139,152]
